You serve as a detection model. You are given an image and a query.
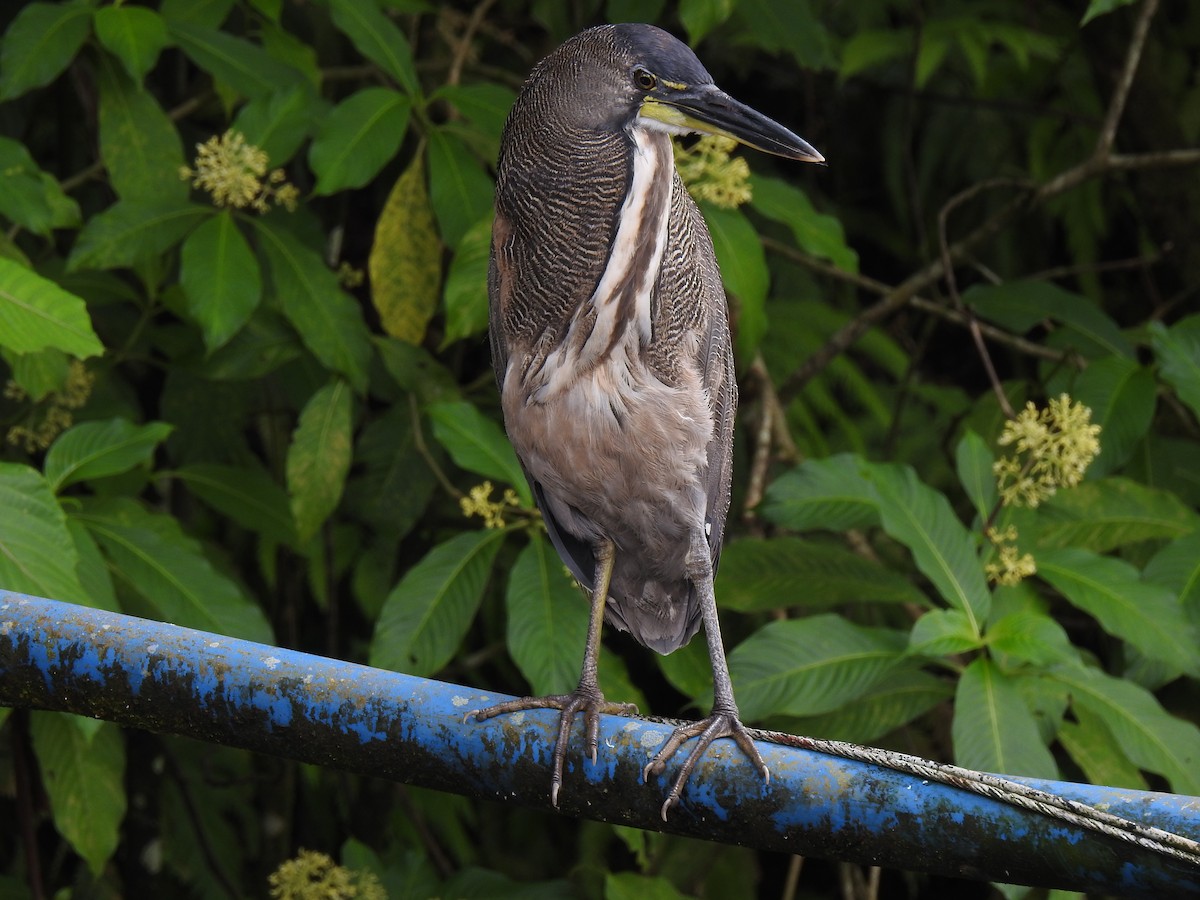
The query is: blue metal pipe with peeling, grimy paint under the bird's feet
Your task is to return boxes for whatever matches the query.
[0,592,1200,899]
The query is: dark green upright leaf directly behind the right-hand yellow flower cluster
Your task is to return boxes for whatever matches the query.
[1072,355,1156,479]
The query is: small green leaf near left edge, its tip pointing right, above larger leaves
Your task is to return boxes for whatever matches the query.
[44,419,172,493]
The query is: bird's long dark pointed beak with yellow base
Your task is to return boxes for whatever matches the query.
[641,84,824,162]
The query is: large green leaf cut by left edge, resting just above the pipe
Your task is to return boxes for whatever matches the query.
[0,462,88,604]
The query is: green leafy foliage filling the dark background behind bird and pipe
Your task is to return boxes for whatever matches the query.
[0,0,1200,898]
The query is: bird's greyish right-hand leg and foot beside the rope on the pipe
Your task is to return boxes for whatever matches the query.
[642,534,770,822]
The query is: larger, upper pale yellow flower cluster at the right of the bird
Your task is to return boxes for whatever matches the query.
[992,394,1100,508]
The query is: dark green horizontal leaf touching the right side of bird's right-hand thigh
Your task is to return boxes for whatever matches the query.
[716,536,929,612]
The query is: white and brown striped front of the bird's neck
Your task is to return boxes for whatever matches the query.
[530,126,674,400]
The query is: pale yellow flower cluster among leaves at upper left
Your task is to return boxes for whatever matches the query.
[179,130,300,212]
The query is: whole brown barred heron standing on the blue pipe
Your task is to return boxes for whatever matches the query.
[467,24,824,820]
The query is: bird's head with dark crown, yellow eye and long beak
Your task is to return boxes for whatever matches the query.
[526,24,824,162]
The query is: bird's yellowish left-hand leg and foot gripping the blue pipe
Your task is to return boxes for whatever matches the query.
[463,540,638,806]
